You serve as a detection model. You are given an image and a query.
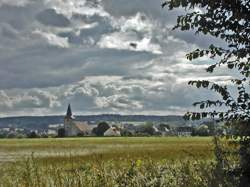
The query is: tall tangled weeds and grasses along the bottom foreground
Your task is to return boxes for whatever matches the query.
[0,156,238,187]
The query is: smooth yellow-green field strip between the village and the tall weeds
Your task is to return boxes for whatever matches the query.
[0,137,212,162]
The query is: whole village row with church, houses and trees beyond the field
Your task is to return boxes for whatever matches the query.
[0,104,227,138]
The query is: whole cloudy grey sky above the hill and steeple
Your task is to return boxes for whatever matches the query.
[0,0,230,117]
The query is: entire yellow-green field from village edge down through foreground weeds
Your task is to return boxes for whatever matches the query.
[0,137,238,187]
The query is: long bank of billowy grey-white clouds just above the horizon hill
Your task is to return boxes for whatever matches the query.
[0,71,219,115]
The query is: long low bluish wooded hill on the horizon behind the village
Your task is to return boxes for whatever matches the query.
[0,114,190,130]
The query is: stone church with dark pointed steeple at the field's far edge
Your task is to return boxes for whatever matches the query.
[64,104,92,136]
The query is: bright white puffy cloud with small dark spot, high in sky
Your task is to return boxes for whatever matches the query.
[97,13,162,54]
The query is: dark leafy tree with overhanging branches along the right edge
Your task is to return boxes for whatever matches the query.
[162,0,250,186]
